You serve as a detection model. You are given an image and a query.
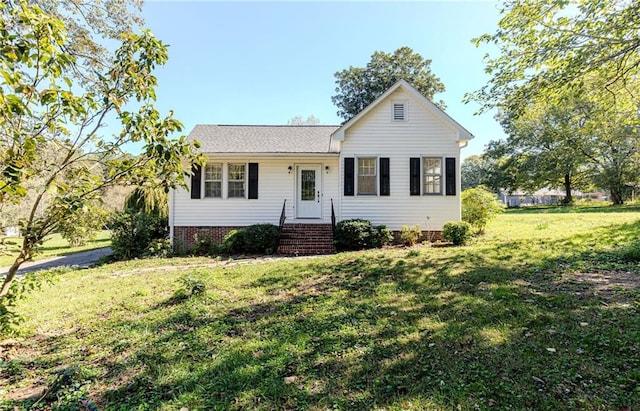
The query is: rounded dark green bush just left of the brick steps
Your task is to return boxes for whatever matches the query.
[220,224,280,254]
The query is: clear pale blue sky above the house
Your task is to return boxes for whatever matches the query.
[143,1,503,157]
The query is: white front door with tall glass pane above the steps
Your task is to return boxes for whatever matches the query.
[296,165,322,218]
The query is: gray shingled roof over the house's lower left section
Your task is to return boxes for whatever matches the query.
[188,124,339,153]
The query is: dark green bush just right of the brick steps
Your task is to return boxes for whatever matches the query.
[333,219,393,251]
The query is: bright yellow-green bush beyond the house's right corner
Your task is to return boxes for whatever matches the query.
[462,186,504,234]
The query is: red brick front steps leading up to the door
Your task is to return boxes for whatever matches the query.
[278,224,335,255]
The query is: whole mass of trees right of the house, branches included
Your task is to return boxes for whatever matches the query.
[462,0,640,204]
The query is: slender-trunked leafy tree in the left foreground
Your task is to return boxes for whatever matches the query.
[0,1,202,308]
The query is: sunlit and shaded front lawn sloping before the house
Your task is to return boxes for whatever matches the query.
[0,207,640,410]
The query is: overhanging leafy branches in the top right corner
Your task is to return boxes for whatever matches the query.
[468,0,640,114]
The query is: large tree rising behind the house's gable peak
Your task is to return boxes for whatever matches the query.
[331,46,445,121]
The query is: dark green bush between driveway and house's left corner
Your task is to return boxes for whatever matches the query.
[109,211,169,260]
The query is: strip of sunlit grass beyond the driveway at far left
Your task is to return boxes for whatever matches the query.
[0,230,111,267]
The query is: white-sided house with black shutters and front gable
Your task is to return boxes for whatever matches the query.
[169,80,473,253]
